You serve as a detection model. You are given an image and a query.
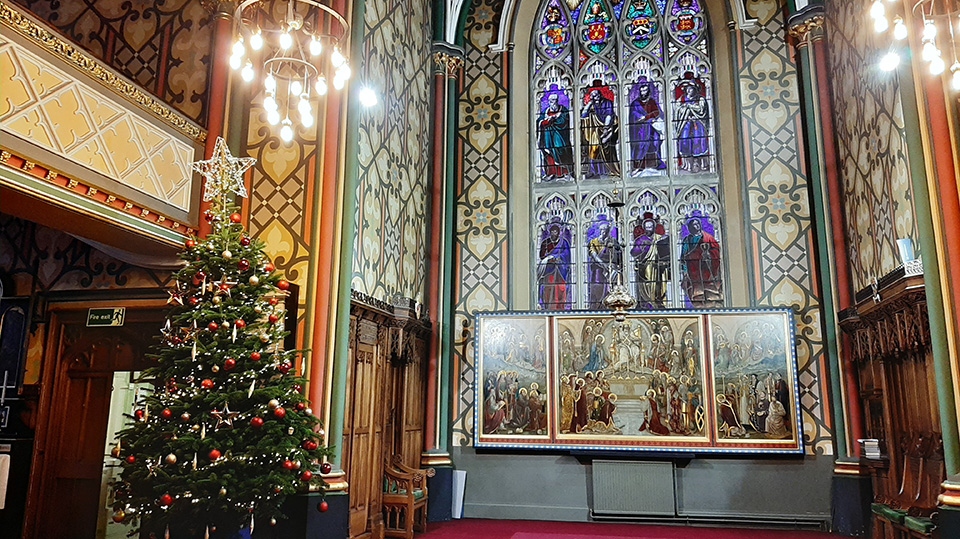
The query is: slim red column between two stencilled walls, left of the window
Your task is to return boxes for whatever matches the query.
[423,58,447,451]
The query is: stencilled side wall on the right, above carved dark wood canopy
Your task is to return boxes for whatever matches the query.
[825,0,919,290]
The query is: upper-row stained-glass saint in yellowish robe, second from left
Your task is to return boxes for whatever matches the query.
[580,80,620,178]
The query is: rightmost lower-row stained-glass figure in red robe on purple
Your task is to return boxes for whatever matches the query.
[680,211,723,308]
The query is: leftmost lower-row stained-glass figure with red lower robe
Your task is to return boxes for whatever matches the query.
[537,221,573,311]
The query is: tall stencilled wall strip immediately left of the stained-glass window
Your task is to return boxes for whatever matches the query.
[451,0,510,445]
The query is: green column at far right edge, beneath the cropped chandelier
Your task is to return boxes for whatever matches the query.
[897,49,960,476]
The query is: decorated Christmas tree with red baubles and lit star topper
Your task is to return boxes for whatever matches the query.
[112,139,329,539]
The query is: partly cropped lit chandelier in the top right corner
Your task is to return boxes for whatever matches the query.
[870,0,960,91]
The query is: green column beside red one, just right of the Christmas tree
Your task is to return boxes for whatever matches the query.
[327,0,366,467]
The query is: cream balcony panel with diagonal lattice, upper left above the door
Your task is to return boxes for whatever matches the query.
[0,31,195,212]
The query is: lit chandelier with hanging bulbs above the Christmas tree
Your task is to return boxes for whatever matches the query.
[230,0,350,142]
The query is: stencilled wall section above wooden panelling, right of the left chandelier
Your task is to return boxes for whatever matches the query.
[351,0,433,303]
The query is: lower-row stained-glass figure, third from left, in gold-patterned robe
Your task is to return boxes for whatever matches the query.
[630,212,670,309]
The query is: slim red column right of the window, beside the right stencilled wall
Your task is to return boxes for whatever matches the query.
[810,34,864,458]
